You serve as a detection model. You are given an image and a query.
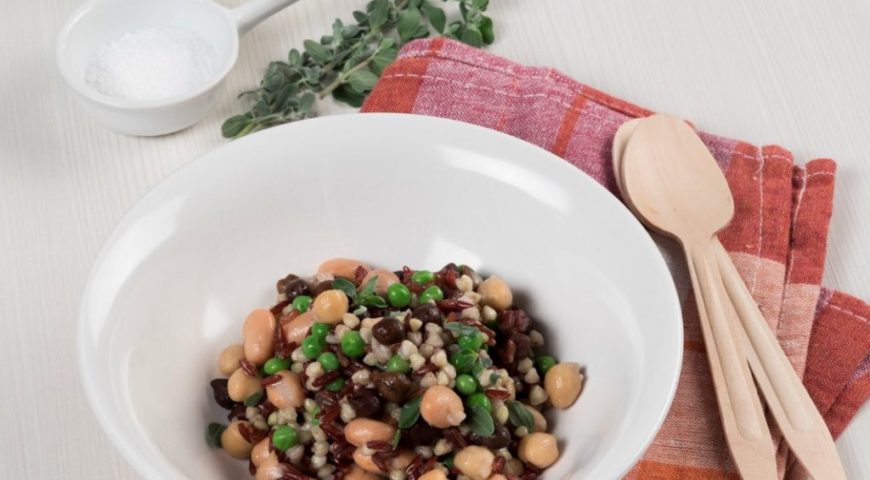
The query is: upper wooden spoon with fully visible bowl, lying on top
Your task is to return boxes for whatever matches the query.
[622,115,776,479]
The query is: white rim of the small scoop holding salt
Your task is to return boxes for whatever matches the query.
[55,0,239,111]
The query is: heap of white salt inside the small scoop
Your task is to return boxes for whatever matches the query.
[85,27,219,101]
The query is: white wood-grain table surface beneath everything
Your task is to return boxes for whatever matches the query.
[0,0,870,479]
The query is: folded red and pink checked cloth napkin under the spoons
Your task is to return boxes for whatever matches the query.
[363,39,870,479]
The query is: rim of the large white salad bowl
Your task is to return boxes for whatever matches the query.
[76,113,683,478]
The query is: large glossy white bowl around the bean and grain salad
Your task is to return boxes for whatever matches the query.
[78,114,682,479]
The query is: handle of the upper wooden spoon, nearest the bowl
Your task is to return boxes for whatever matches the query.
[683,240,776,480]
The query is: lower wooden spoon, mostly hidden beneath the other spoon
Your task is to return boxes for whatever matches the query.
[613,119,846,480]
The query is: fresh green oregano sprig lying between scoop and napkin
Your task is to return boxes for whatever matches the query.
[221,0,494,138]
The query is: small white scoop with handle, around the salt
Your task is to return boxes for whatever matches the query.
[57,0,296,136]
